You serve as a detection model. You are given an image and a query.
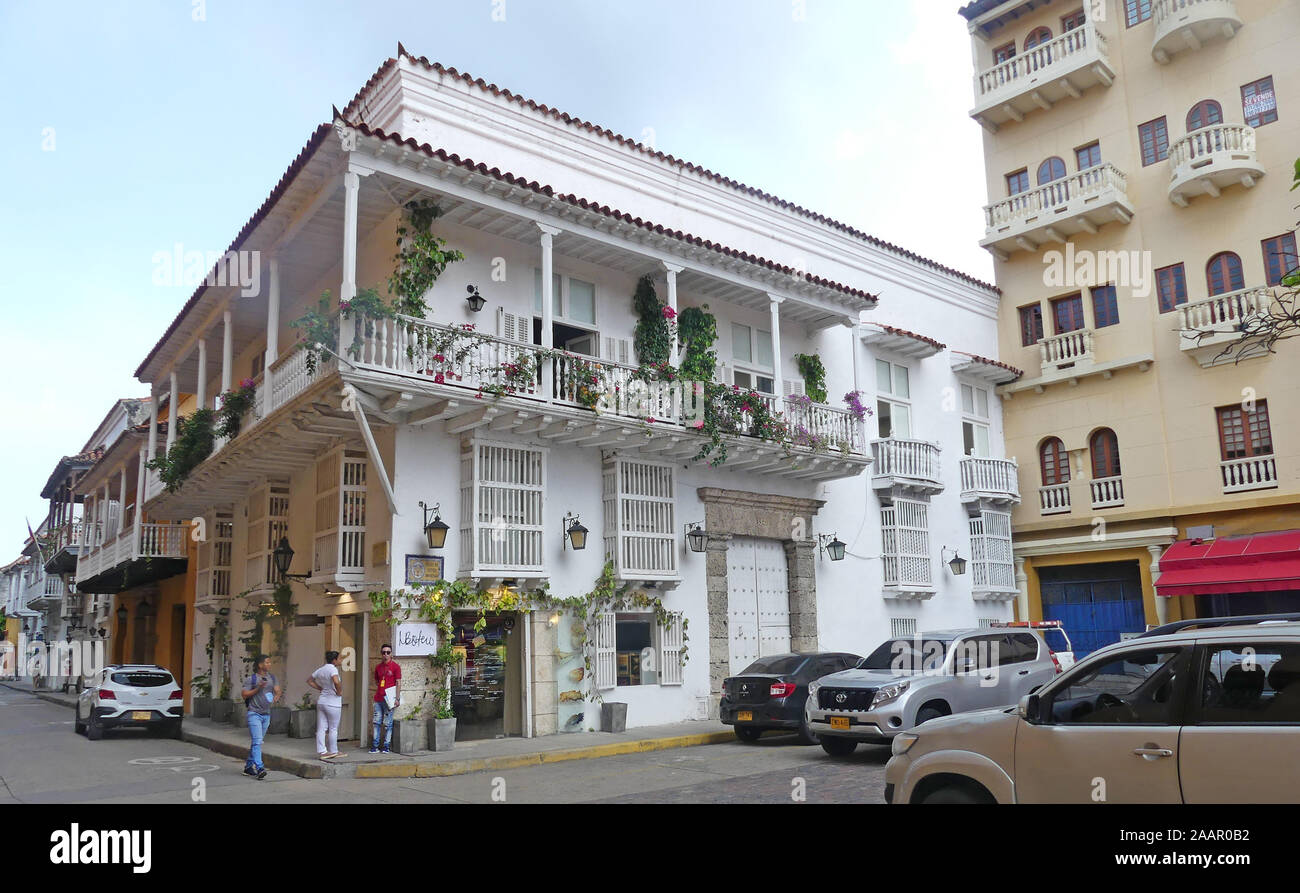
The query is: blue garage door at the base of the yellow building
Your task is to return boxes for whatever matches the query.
[1039,562,1147,658]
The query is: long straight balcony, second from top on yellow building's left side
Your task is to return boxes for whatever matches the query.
[980,161,1135,260]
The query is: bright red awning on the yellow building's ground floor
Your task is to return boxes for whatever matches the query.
[1156,530,1300,598]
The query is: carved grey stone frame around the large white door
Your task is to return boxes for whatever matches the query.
[696,487,826,719]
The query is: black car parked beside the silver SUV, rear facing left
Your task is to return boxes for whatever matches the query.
[718,651,862,744]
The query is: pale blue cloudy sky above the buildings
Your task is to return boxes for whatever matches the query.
[0,0,993,551]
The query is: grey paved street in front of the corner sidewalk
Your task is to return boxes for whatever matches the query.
[0,689,889,803]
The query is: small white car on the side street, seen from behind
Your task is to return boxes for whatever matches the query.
[73,664,185,741]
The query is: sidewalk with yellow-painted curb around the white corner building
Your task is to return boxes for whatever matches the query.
[0,682,736,779]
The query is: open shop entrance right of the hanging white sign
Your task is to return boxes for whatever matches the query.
[450,611,524,741]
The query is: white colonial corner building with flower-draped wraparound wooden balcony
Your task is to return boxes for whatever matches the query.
[124,48,1019,737]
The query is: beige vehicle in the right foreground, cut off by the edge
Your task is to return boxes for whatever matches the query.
[885,621,1300,803]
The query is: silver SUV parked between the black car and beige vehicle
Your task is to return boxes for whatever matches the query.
[805,629,1061,757]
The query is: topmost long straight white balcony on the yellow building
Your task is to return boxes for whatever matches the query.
[971,22,1115,133]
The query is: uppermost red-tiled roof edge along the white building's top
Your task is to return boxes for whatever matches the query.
[343,46,1002,294]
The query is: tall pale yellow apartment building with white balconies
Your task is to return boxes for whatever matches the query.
[961,0,1300,653]
